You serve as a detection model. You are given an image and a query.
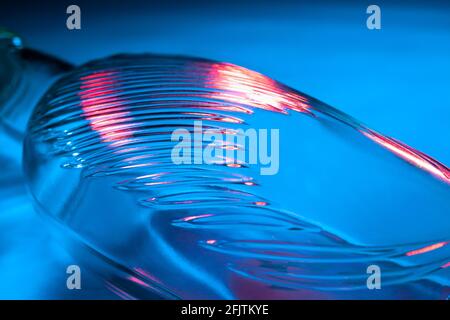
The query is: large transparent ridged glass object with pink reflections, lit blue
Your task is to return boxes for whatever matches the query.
[24,55,450,299]
